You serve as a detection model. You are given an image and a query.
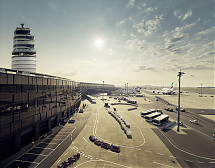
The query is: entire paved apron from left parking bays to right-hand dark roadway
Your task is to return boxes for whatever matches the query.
[3,94,215,168]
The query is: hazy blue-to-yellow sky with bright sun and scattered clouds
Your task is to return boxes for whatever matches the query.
[0,0,215,86]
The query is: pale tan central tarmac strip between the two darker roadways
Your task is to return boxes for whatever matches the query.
[52,97,181,168]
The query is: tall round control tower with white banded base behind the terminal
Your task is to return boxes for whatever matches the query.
[11,23,36,72]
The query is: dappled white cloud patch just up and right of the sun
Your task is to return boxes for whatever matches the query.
[133,15,163,36]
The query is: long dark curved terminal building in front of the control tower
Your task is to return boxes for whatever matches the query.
[0,69,81,160]
